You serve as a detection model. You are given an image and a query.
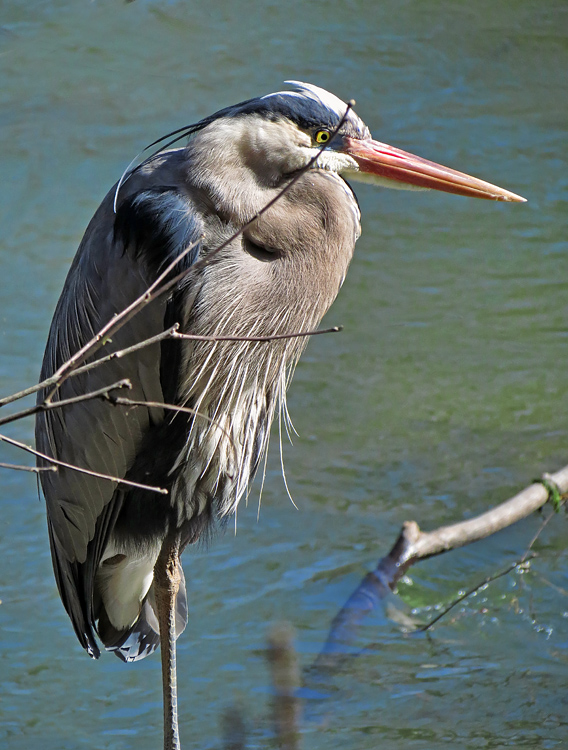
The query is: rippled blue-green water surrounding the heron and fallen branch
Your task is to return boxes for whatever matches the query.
[0,0,568,750]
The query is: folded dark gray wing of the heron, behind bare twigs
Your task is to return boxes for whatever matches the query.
[36,180,201,657]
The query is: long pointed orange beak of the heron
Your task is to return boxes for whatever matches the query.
[343,136,526,203]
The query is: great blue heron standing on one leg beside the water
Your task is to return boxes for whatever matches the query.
[37,82,523,748]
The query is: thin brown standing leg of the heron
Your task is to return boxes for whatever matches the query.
[154,534,181,750]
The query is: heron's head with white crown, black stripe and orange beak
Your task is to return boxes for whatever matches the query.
[193,81,525,202]
